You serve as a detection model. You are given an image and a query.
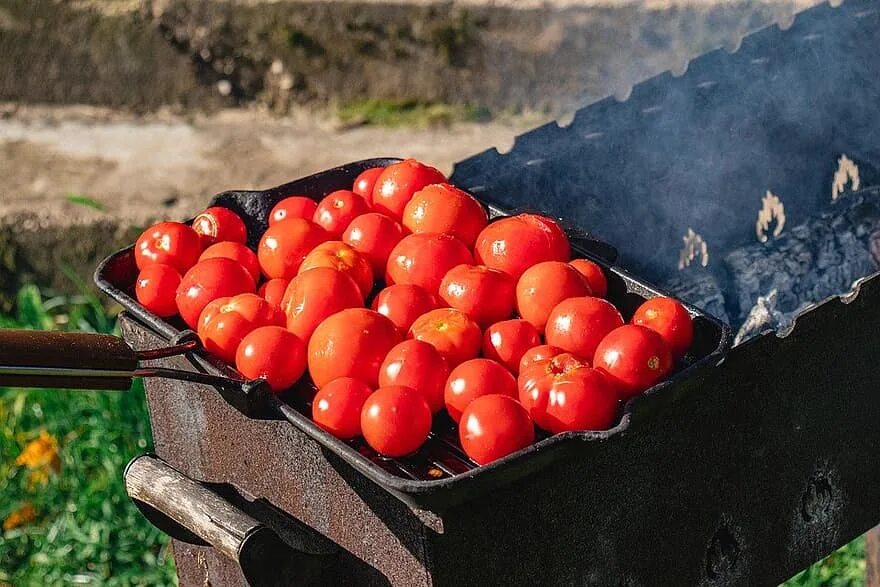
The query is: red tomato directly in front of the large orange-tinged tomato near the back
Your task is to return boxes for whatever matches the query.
[385,234,473,293]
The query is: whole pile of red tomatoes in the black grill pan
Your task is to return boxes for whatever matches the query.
[135,159,693,464]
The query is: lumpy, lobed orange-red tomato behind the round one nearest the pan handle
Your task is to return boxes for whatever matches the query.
[198,293,284,363]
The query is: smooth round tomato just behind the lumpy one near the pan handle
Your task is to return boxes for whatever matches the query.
[175,257,256,329]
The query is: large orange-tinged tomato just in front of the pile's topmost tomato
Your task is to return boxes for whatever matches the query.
[403,183,489,248]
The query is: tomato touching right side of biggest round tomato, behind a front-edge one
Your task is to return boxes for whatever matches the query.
[379,340,449,414]
